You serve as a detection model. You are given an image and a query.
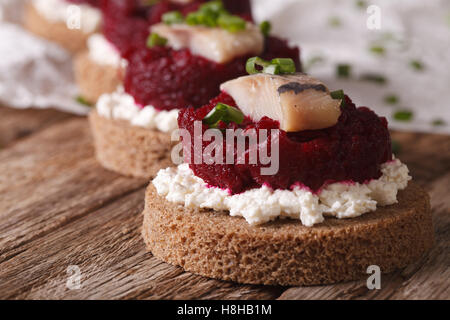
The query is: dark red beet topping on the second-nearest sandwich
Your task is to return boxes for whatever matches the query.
[124,37,301,110]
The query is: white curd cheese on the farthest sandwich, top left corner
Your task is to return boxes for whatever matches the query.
[32,0,102,33]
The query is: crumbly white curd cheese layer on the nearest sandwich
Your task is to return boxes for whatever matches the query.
[152,159,411,227]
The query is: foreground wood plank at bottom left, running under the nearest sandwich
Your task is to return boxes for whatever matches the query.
[0,189,281,299]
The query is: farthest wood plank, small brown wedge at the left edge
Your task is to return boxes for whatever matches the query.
[0,106,75,148]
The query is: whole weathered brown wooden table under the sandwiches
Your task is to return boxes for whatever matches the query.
[0,108,450,299]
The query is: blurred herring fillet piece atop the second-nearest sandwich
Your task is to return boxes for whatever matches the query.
[151,23,264,63]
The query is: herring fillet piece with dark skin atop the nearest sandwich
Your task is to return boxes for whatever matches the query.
[220,73,341,132]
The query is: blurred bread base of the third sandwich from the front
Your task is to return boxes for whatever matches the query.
[74,51,123,104]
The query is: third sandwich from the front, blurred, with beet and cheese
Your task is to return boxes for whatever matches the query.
[74,0,223,104]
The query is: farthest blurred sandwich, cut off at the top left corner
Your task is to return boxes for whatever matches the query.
[24,0,102,53]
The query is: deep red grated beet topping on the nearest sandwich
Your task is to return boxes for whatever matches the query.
[178,93,392,194]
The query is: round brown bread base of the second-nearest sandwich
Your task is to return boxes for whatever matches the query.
[89,111,173,179]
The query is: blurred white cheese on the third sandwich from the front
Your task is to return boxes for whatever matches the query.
[87,33,128,69]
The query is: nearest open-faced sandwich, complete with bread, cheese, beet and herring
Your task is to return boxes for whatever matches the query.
[143,58,433,285]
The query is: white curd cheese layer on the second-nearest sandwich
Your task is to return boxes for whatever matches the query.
[96,87,179,133]
